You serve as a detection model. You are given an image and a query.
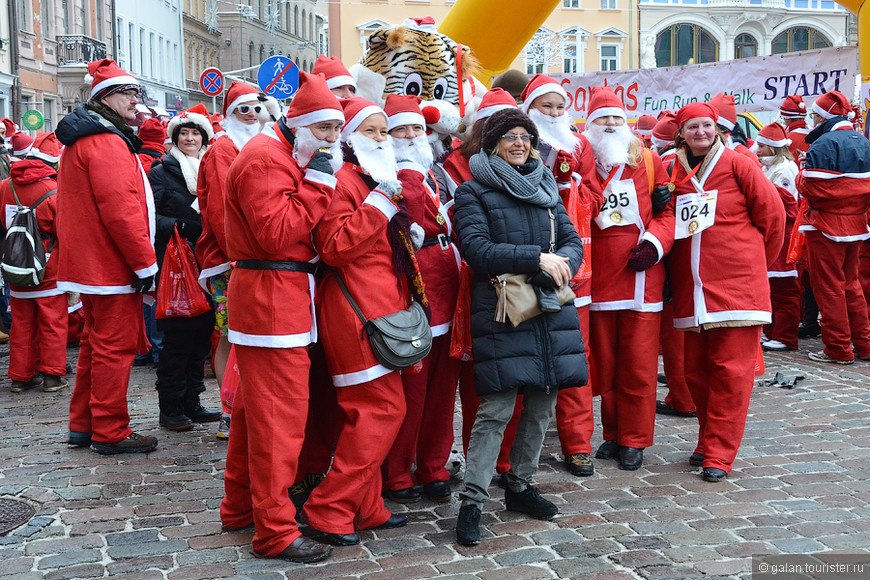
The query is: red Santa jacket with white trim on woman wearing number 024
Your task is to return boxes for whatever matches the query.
[670,146,785,328]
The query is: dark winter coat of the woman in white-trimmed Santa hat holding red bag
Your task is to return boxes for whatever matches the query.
[148,155,202,269]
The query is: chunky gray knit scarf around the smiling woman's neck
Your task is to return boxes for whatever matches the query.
[468,151,559,208]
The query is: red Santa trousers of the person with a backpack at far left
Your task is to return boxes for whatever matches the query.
[9,294,68,382]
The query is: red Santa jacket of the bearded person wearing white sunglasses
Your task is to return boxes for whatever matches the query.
[196,135,239,283]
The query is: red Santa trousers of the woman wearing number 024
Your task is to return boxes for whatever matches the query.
[686,326,761,472]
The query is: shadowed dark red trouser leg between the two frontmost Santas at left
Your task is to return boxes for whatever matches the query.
[293,343,344,484]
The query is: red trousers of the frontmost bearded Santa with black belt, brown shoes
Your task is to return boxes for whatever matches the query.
[221,344,310,557]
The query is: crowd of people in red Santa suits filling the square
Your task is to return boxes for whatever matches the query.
[0,57,870,562]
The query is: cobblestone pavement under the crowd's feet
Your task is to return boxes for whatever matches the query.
[0,340,870,580]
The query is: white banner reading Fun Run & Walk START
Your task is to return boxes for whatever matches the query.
[553,46,858,120]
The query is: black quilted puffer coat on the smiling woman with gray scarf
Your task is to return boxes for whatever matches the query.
[454,168,587,396]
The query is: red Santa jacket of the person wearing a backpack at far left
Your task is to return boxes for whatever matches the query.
[0,159,63,298]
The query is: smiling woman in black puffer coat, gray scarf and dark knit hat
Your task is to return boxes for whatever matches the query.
[454,109,587,545]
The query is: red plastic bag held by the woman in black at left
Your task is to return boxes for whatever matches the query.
[154,226,211,318]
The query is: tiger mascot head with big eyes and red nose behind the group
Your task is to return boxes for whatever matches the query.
[349,17,486,158]
